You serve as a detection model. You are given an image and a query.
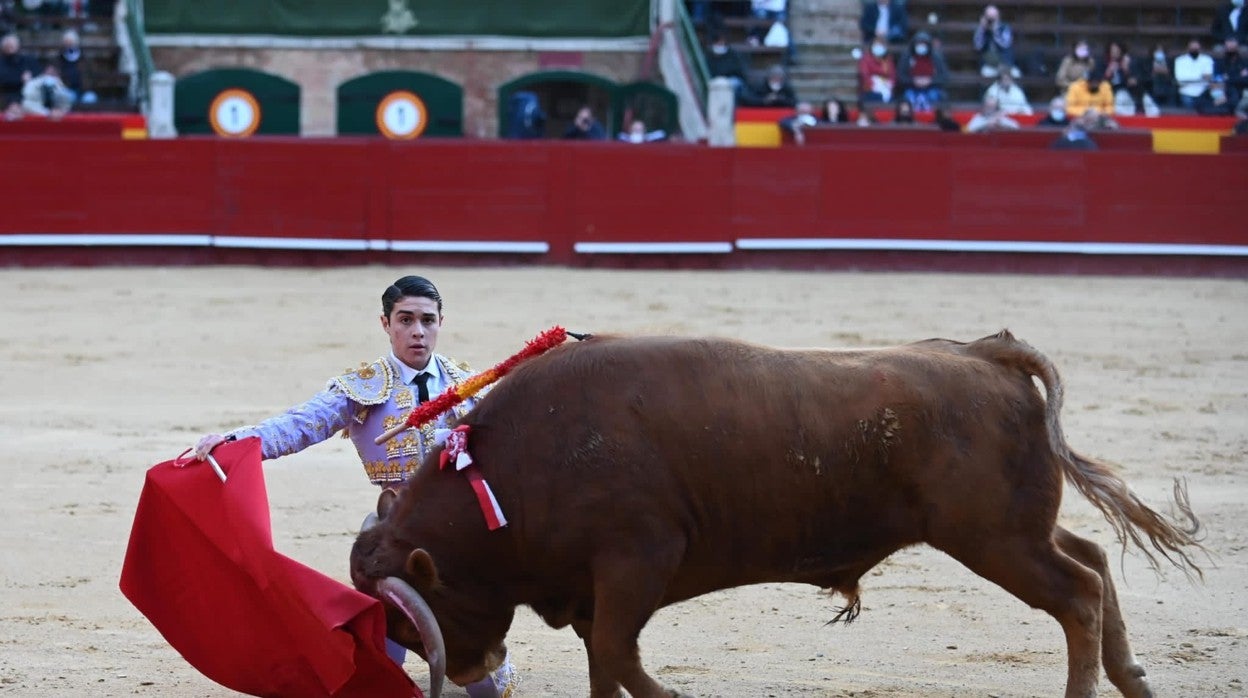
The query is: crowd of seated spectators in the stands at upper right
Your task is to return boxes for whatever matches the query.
[695,0,1248,142]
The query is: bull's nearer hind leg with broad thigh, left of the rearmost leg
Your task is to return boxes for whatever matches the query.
[938,536,1102,698]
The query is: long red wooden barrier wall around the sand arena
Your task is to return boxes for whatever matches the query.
[0,137,1248,273]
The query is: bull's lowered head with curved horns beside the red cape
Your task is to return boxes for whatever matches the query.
[351,489,510,698]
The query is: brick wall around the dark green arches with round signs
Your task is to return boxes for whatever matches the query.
[152,46,645,137]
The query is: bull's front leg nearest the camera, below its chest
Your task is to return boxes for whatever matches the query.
[588,549,680,698]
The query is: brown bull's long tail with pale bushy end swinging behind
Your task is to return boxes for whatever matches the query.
[976,331,1204,579]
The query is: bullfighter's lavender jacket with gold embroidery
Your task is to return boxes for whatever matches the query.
[231,355,477,484]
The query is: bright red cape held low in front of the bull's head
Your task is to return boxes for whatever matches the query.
[121,438,422,698]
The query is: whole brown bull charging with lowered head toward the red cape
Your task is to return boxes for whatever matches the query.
[351,332,1199,698]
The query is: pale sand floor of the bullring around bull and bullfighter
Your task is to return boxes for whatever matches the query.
[0,267,1248,698]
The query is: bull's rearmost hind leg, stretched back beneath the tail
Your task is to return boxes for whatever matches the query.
[1053,527,1153,698]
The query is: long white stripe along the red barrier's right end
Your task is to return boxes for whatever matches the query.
[736,237,1248,257]
